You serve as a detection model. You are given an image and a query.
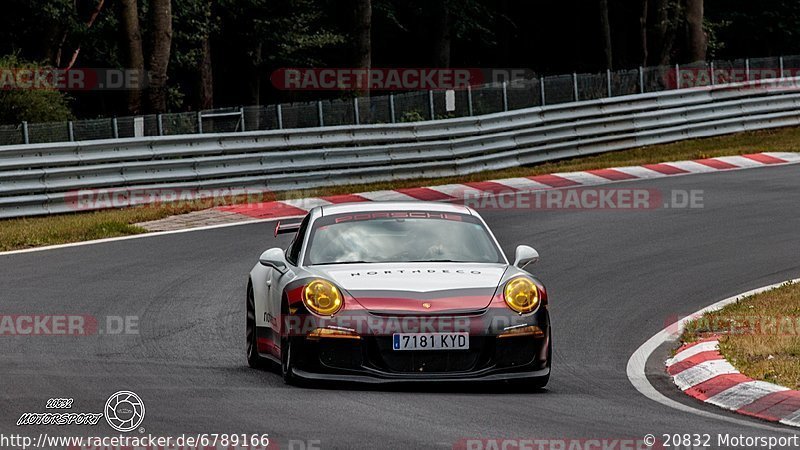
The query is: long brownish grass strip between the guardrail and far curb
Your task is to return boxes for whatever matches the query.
[0,127,800,251]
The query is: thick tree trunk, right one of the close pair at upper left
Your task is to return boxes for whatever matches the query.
[149,0,172,113]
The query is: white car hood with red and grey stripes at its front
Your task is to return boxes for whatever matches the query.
[307,263,508,314]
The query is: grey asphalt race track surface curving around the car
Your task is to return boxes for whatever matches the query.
[0,165,800,448]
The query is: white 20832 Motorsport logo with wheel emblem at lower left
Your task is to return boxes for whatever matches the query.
[17,391,145,433]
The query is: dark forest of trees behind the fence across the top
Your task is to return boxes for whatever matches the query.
[0,0,800,121]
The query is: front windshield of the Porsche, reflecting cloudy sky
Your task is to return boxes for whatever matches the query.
[305,211,504,265]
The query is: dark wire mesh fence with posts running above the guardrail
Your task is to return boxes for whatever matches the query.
[0,55,800,146]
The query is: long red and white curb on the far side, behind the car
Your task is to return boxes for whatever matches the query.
[137,152,800,231]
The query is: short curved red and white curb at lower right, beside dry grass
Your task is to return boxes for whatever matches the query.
[666,337,800,427]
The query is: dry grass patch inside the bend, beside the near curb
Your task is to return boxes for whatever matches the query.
[681,283,800,389]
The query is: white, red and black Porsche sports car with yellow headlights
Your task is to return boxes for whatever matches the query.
[247,202,552,388]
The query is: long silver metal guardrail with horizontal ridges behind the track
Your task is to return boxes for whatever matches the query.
[0,77,800,218]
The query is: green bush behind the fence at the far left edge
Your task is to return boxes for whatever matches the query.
[0,55,72,124]
